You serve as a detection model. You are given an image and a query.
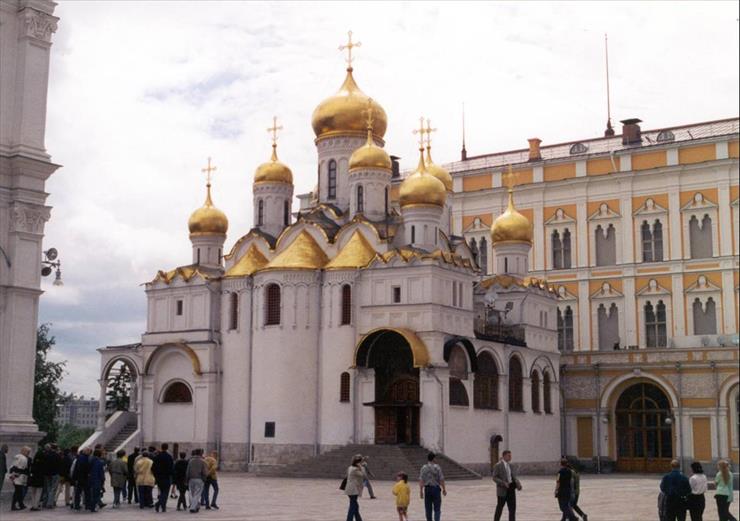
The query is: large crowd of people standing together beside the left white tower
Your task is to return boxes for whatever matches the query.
[0,443,219,513]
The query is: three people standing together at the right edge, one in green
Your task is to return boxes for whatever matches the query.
[658,460,737,521]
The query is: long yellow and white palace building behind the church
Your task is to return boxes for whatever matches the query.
[445,118,740,470]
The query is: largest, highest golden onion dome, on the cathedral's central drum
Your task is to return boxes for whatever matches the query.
[311,67,388,139]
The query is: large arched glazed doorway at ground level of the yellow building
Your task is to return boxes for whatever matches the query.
[614,382,673,472]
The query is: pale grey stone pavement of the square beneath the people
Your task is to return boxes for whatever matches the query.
[0,473,738,521]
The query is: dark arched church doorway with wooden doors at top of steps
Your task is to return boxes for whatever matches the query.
[356,329,425,445]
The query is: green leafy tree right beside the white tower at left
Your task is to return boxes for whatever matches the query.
[33,324,67,443]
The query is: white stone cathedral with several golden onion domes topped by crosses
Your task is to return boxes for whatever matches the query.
[95,35,562,470]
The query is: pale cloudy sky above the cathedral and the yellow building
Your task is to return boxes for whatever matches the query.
[40,1,739,395]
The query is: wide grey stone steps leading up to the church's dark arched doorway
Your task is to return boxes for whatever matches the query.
[256,445,481,482]
